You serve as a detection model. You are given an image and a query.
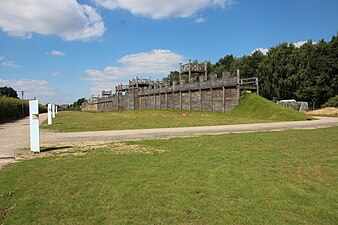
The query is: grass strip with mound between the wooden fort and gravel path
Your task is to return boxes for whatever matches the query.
[42,94,306,132]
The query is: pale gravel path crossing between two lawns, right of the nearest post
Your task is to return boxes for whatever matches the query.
[41,117,338,143]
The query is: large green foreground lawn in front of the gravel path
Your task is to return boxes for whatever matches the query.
[0,127,338,224]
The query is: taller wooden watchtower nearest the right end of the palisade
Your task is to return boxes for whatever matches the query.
[180,59,208,83]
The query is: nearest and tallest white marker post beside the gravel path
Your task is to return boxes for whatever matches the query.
[29,100,40,152]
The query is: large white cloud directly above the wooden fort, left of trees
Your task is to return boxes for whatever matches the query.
[84,49,185,94]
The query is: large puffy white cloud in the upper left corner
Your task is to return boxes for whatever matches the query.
[0,0,105,41]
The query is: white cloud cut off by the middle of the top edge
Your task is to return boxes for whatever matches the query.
[94,0,234,19]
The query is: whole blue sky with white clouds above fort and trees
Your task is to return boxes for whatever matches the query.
[0,0,338,104]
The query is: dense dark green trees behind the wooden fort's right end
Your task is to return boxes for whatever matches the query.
[164,35,338,106]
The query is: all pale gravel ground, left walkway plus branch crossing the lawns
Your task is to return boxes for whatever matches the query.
[0,114,338,168]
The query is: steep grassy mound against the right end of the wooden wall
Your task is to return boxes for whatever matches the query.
[227,93,306,121]
